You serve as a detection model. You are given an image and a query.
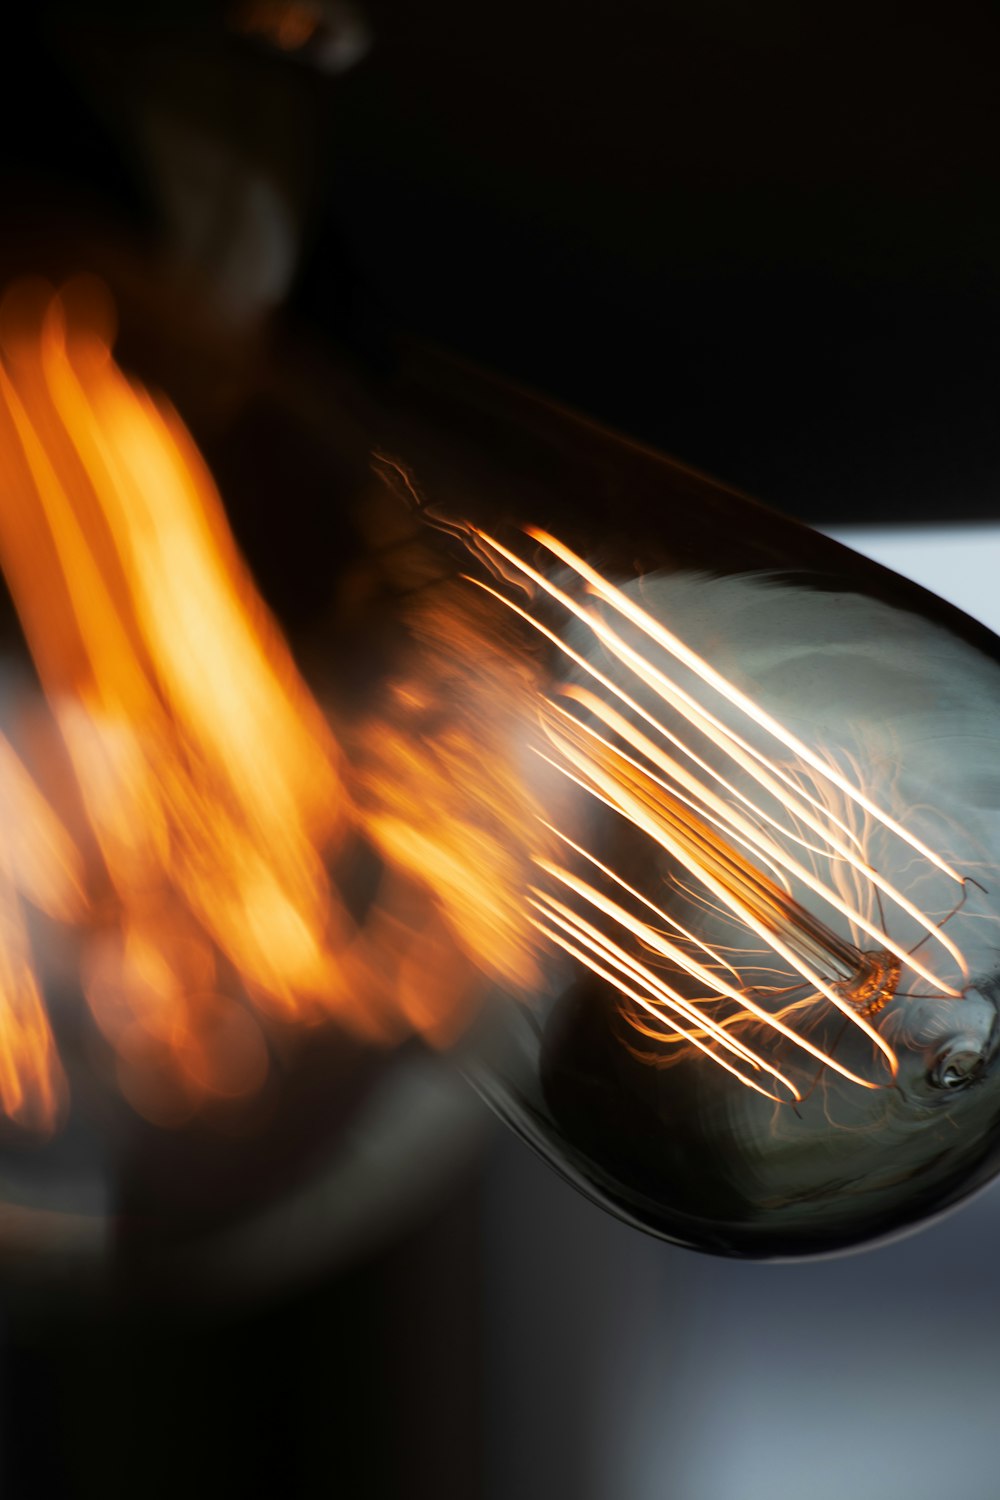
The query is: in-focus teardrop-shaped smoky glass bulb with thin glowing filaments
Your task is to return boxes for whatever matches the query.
[364,357,1000,1257]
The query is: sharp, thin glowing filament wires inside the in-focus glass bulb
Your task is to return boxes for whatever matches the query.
[471,530,967,1101]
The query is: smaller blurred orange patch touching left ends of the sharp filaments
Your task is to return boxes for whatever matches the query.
[352,581,552,990]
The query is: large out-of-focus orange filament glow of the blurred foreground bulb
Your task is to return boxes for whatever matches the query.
[0,284,542,1127]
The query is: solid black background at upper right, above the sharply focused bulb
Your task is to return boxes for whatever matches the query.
[318,0,1000,521]
